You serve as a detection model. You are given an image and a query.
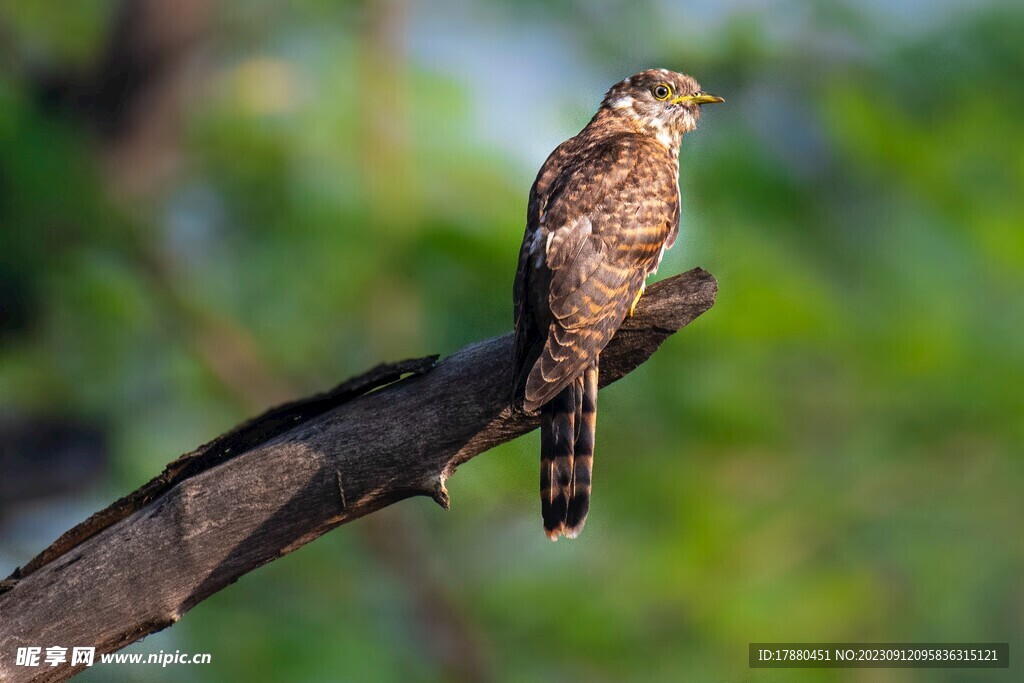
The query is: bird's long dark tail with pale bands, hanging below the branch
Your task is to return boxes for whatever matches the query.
[541,362,597,541]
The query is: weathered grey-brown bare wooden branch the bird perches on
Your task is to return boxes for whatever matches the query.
[0,268,717,681]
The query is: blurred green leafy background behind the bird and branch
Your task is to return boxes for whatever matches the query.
[0,0,1024,682]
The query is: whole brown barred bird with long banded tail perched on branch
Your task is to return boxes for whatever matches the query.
[513,69,725,541]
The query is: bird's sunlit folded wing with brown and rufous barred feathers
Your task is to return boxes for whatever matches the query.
[524,135,679,410]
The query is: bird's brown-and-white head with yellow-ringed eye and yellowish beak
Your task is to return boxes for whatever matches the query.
[599,69,725,148]
